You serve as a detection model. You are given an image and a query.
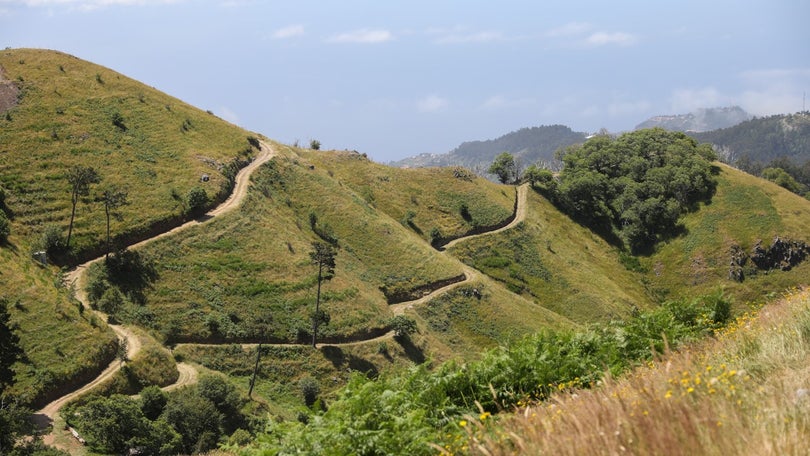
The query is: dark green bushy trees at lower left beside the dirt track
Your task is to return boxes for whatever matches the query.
[62,375,249,456]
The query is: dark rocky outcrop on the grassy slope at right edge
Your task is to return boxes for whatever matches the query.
[728,236,810,282]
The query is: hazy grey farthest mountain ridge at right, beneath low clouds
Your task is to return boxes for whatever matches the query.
[635,106,752,132]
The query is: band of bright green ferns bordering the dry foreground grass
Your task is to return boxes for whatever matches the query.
[240,293,730,455]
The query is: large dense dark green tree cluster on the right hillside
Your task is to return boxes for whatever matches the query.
[516,128,717,252]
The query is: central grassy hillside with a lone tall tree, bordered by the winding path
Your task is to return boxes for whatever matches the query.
[133,147,463,341]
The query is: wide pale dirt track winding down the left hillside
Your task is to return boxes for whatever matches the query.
[34,142,276,444]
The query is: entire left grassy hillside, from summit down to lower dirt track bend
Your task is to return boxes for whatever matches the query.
[0,49,250,403]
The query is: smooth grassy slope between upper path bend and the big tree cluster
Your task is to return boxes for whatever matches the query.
[450,192,649,323]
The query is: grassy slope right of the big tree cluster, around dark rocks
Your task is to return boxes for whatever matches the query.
[642,165,810,304]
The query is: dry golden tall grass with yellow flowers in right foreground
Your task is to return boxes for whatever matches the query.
[466,289,810,455]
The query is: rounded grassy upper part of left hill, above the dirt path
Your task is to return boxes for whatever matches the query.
[0,49,252,258]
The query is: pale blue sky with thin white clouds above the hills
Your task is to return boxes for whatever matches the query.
[0,0,810,162]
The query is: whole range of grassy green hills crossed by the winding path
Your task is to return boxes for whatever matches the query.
[0,50,810,454]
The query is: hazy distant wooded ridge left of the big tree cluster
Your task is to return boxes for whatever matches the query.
[390,125,587,172]
